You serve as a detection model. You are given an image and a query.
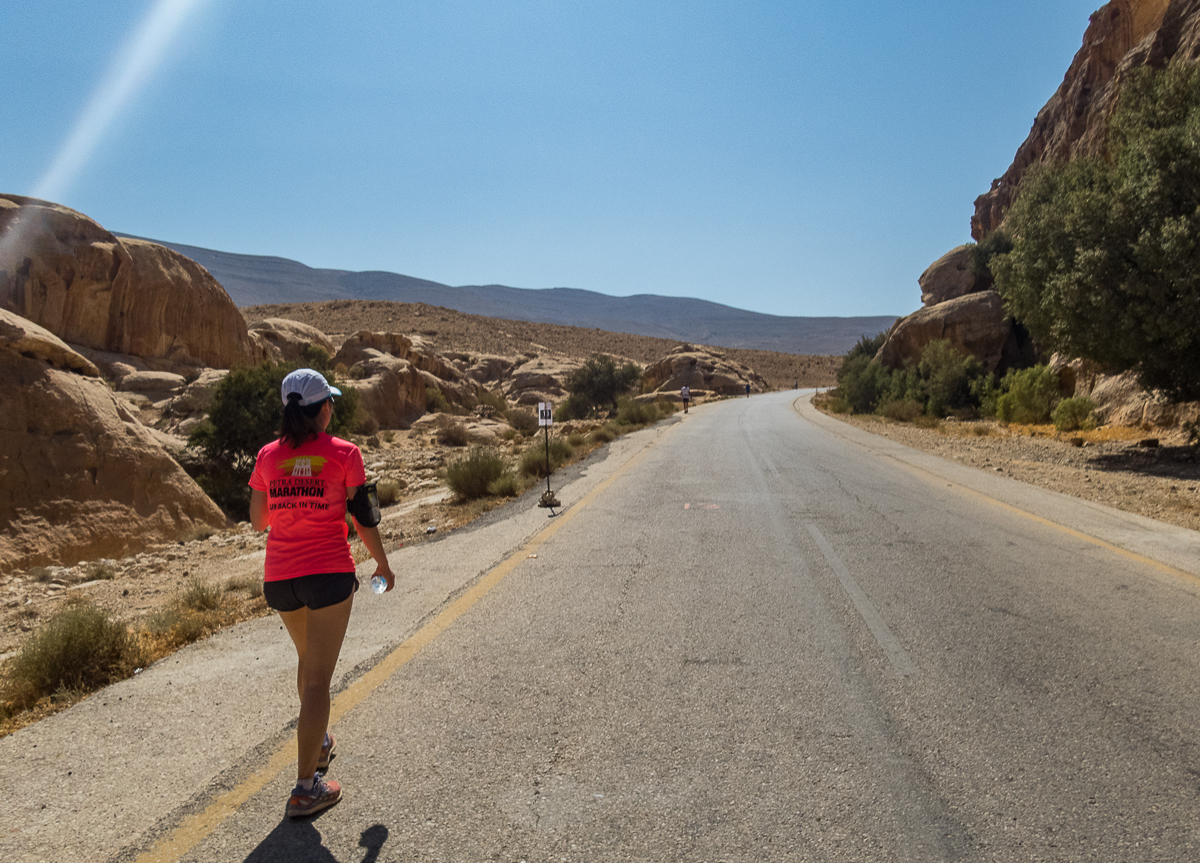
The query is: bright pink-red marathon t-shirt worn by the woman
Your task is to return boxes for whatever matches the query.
[250,435,366,581]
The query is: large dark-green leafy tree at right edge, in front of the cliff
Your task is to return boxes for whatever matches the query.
[990,62,1200,400]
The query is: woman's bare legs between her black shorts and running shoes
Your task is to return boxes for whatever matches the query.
[280,594,354,779]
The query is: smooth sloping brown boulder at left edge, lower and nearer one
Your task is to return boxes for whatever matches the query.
[0,312,227,570]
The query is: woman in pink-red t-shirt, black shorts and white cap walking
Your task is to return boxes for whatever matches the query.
[250,368,396,817]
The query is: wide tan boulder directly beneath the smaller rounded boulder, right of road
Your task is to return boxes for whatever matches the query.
[875,290,1020,371]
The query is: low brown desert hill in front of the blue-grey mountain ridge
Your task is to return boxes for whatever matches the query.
[241,300,841,389]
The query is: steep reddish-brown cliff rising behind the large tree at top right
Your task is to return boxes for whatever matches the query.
[971,0,1176,240]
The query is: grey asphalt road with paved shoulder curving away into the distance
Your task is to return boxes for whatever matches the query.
[9,392,1200,863]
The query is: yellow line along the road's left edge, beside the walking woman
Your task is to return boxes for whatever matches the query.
[137,424,678,863]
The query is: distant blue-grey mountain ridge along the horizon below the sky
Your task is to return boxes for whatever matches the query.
[114,232,895,354]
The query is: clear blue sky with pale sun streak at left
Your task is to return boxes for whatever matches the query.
[0,0,1100,316]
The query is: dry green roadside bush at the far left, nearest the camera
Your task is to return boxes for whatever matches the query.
[8,599,144,709]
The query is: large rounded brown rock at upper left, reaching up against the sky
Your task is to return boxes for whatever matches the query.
[0,194,275,370]
